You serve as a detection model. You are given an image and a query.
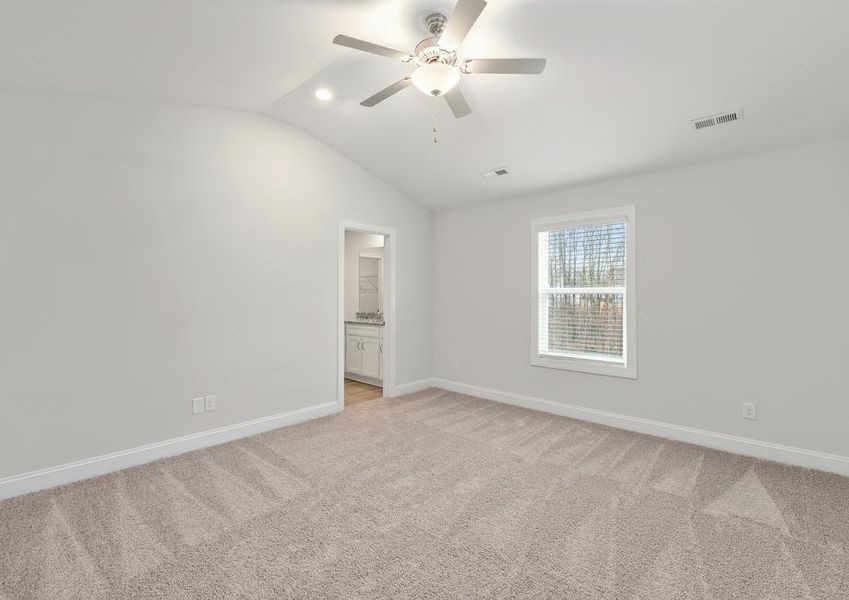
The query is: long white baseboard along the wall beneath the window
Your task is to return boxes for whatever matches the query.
[431,378,849,476]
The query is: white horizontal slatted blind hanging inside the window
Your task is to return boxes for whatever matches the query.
[537,219,627,365]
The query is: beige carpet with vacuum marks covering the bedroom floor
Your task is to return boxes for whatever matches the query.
[0,390,849,600]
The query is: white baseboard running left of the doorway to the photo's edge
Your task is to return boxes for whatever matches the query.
[0,402,339,500]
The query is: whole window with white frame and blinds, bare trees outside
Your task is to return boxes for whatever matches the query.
[531,207,637,378]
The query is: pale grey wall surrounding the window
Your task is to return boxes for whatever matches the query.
[433,140,849,456]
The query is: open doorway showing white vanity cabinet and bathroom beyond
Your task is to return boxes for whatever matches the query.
[337,222,395,410]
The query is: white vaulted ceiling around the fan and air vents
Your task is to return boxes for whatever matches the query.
[0,0,849,209]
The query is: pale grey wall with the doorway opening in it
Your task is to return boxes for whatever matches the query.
[0,93,432,478]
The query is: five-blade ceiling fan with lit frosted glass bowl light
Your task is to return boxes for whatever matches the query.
[333,0,545,119]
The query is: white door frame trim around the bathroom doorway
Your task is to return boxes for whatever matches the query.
[336,221,396,410]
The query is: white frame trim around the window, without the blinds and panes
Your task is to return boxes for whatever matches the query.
[530,206,637,379]
